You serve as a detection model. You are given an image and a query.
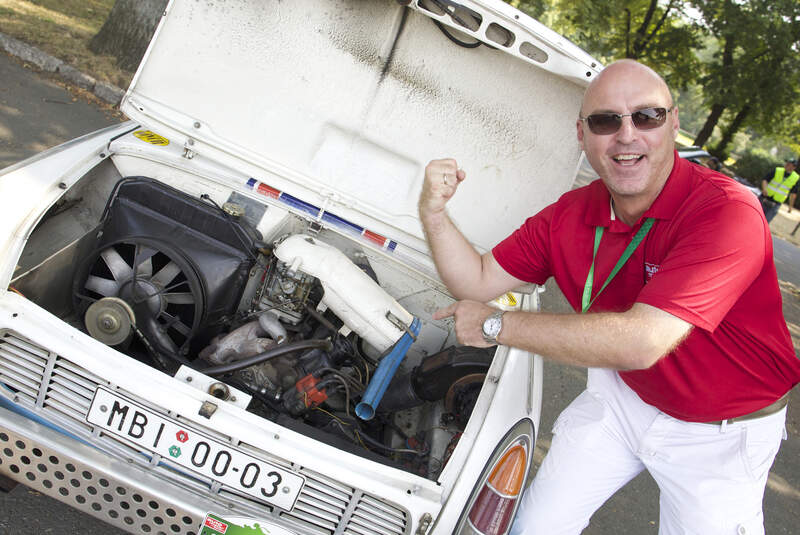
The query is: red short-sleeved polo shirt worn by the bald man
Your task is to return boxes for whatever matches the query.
[492,153,800,422]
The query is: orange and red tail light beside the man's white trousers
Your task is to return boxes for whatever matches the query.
[456,420,534,535]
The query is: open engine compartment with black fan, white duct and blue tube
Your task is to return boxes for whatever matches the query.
[12,164,494,479]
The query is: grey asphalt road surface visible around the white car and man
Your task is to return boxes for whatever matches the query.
[0,53,800,535]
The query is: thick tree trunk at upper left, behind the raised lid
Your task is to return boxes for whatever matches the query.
[89,0,167,71]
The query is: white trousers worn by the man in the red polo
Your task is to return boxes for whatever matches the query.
[511,369,786,535]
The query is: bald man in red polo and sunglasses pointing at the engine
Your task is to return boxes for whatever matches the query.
[419,60,800,535]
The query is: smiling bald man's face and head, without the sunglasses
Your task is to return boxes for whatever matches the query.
[577,63,679,202]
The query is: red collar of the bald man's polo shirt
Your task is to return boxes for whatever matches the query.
[584,151,691,232]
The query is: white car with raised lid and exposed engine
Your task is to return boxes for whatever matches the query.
[0,0,600,535]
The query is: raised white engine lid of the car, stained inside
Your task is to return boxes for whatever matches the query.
[122,0,600,250]
